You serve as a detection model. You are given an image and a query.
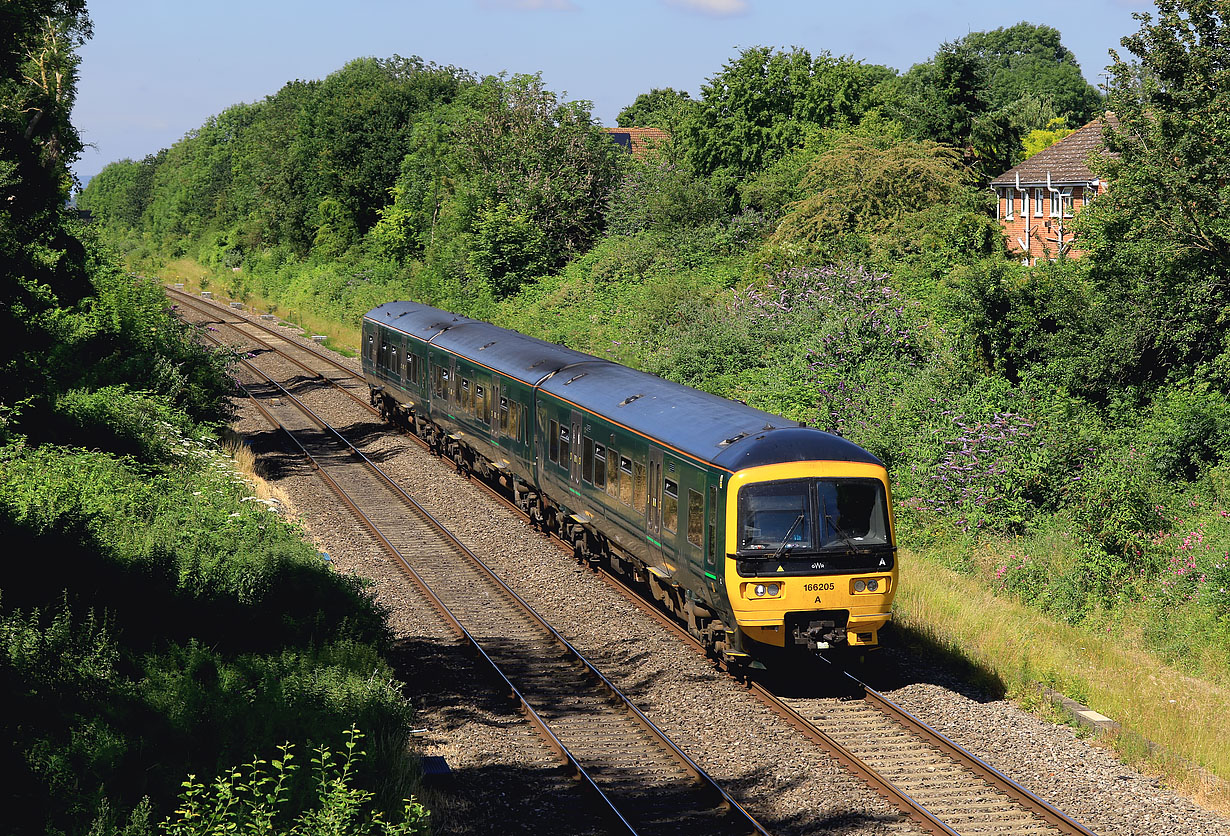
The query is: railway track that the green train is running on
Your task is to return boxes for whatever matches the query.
[168,287,1092,836]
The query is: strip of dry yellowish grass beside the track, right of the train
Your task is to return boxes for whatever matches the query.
[895,552,1230,811]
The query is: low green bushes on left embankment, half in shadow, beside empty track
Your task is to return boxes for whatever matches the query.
[0,440,410,832]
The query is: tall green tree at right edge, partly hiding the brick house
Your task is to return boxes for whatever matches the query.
[1079,0,1230,390]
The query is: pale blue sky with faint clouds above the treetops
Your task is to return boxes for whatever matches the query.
[73,0,1153,179]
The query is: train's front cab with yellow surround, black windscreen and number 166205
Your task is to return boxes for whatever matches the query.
[724,461,898,659]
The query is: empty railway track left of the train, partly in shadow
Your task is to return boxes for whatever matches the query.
[210,317,766,836]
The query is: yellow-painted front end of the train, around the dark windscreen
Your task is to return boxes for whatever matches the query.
[726,461,897,648]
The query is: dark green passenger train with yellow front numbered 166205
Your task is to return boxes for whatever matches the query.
[360,301,898,672]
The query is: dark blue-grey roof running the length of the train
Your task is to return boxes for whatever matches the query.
[364,302,882,472]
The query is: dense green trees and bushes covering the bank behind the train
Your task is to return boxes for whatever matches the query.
[74,0,1230,698]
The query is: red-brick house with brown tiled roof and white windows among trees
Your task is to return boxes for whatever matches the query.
[991,113,1114,264]
